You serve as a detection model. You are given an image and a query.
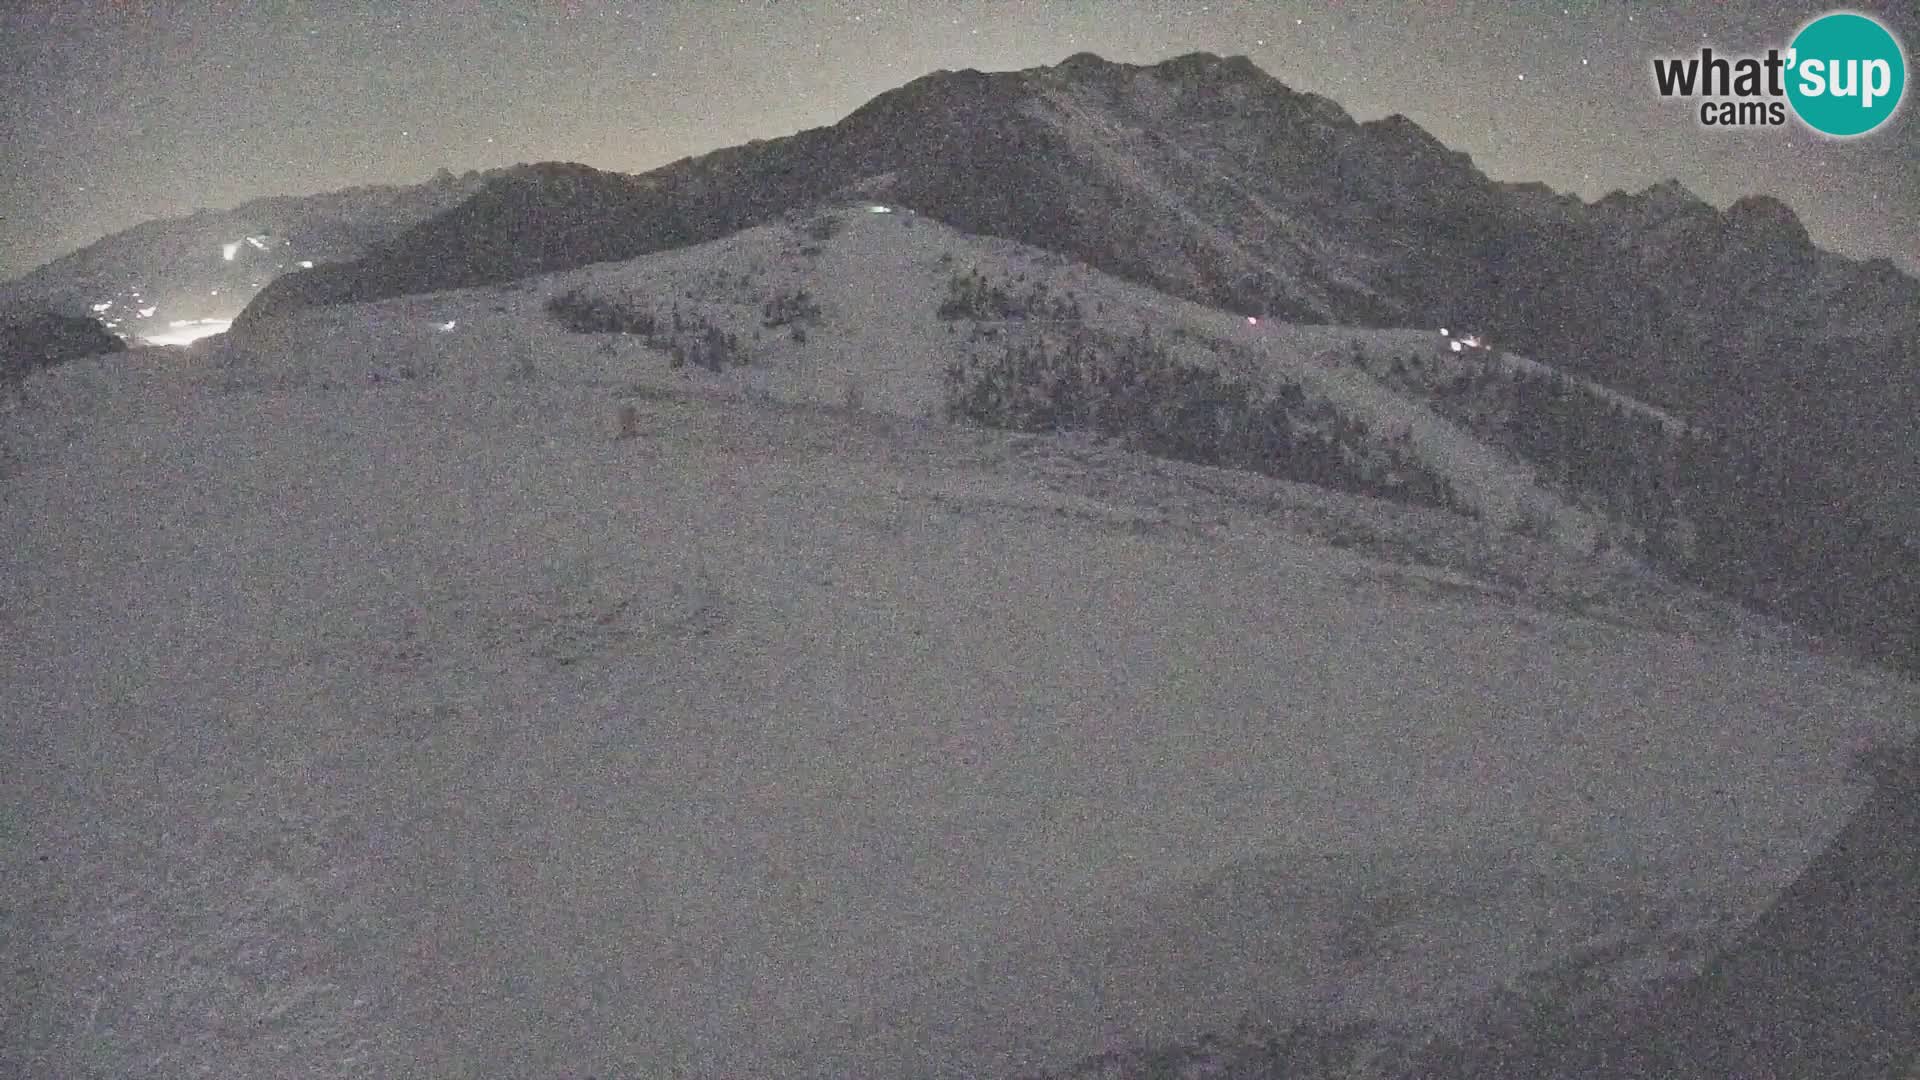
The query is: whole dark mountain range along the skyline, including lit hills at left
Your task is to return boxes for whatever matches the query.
[7,54,1920,668]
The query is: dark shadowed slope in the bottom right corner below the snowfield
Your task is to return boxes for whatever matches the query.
[1402,746,1920,1080]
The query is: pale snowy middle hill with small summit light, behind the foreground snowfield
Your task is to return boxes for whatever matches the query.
[214,202,1766,564]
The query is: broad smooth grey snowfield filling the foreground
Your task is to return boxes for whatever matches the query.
[0,210,1920,1078]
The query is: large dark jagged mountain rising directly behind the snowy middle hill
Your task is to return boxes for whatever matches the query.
[240,54,1920,340]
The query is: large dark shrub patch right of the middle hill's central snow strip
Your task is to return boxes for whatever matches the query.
[945,320,1467,511]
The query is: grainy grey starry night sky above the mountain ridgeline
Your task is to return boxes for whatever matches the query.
[0,0,1920,277]
